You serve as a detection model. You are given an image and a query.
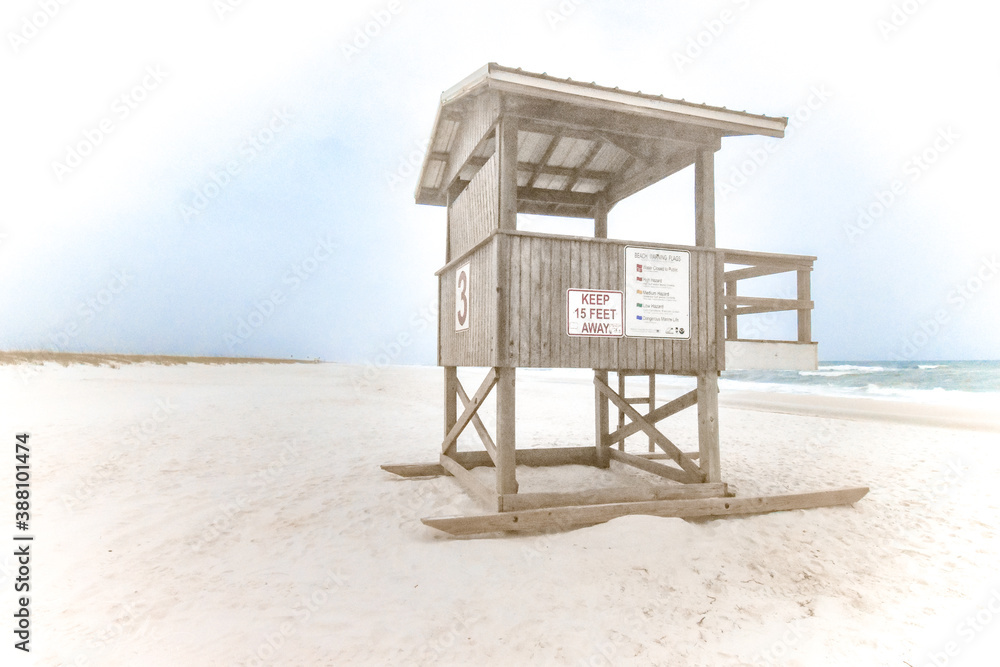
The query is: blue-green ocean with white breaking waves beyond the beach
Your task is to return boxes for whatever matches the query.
[720,361,1000,409]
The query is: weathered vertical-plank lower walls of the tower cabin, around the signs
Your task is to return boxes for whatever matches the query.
[440,232,725,374]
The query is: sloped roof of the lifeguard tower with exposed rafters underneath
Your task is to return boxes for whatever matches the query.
[416,63,788,217]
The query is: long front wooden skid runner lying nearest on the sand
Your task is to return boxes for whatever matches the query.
[421,487,868,536]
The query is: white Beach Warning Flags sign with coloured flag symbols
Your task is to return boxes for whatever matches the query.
[625,246,691,339]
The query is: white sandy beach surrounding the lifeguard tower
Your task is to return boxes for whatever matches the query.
[0,362,1000,667]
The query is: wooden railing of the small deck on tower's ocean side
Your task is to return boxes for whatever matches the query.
[721,250,816,343]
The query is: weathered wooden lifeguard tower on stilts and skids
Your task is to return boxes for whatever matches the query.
[383,63,867,534]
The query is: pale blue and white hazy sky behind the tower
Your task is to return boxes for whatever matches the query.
[0,0,1000,366]
